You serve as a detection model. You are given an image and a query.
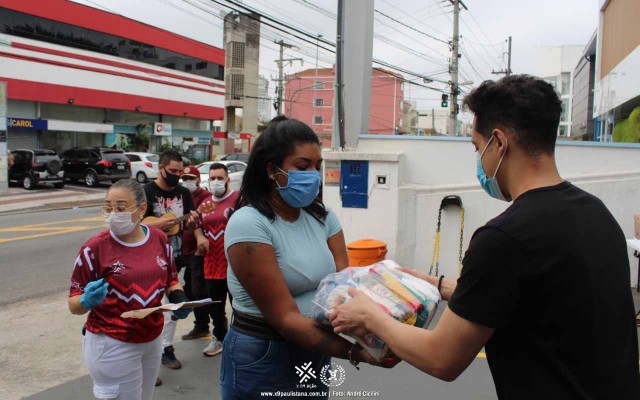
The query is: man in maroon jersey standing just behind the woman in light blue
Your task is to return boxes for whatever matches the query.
[202,163,238,357]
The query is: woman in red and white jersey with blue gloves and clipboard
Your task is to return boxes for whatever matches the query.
[69,179,190,400]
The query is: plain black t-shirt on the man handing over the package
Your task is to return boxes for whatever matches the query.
[449,182,640,400]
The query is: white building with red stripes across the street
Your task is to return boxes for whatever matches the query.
[0,0,225,159]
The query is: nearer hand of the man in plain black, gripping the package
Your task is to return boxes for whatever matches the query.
[329,288,386,336]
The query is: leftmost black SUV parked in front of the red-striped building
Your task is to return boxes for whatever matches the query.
[9,149,64,190]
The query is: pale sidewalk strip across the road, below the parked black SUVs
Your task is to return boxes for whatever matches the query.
[0,185,106,215]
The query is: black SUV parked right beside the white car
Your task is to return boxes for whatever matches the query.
[60,147,131,186]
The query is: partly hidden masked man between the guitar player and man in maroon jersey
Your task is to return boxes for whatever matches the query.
[181,165,211,340]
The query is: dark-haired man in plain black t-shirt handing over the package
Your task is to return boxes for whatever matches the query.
[331,75,640,400]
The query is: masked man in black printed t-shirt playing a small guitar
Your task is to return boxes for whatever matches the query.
[144,150,195,376]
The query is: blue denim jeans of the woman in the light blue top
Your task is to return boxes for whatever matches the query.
[220,328,331,400]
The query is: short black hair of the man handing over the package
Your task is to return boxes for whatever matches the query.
[462,75,562,156]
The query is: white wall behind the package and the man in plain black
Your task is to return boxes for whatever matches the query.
[324,135,640,285]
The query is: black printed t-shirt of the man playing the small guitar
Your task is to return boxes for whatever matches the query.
[144,181,195,257]
